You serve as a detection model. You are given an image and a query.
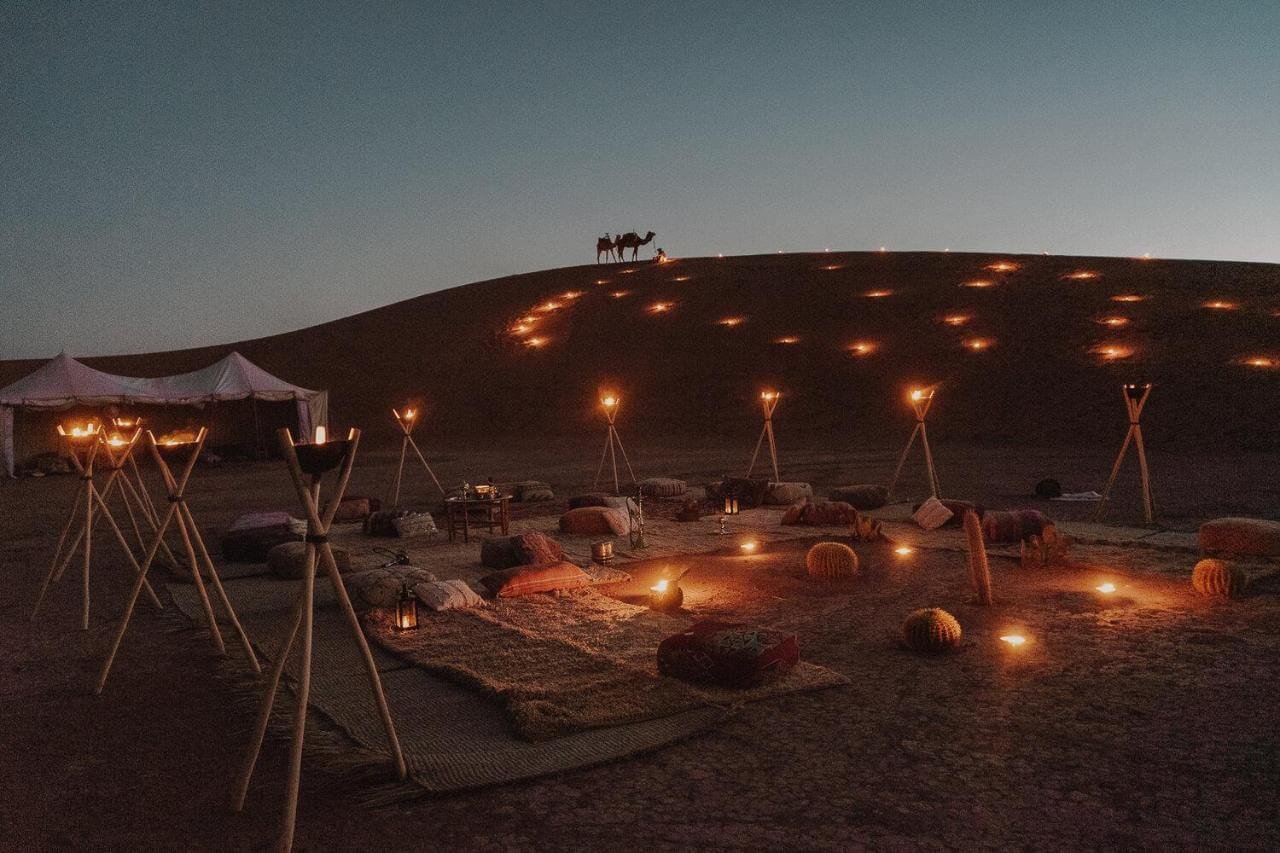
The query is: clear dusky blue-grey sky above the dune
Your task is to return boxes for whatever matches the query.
[0,0,1280,359]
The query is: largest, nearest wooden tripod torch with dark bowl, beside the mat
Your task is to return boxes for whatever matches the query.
[234,428,407,850]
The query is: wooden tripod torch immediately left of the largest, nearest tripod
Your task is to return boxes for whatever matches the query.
[96,427,262,694]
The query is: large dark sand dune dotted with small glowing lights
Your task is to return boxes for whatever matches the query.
[0,252,1280,447]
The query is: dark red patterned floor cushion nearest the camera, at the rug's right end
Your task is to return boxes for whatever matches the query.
[658,620,800,688]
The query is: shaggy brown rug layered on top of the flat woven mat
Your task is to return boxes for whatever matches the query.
[365,589,849,740]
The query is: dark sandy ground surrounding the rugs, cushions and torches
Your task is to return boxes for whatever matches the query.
[0,443,1280,849]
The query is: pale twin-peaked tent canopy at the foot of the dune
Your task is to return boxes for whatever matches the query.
[0,352,329,476]
